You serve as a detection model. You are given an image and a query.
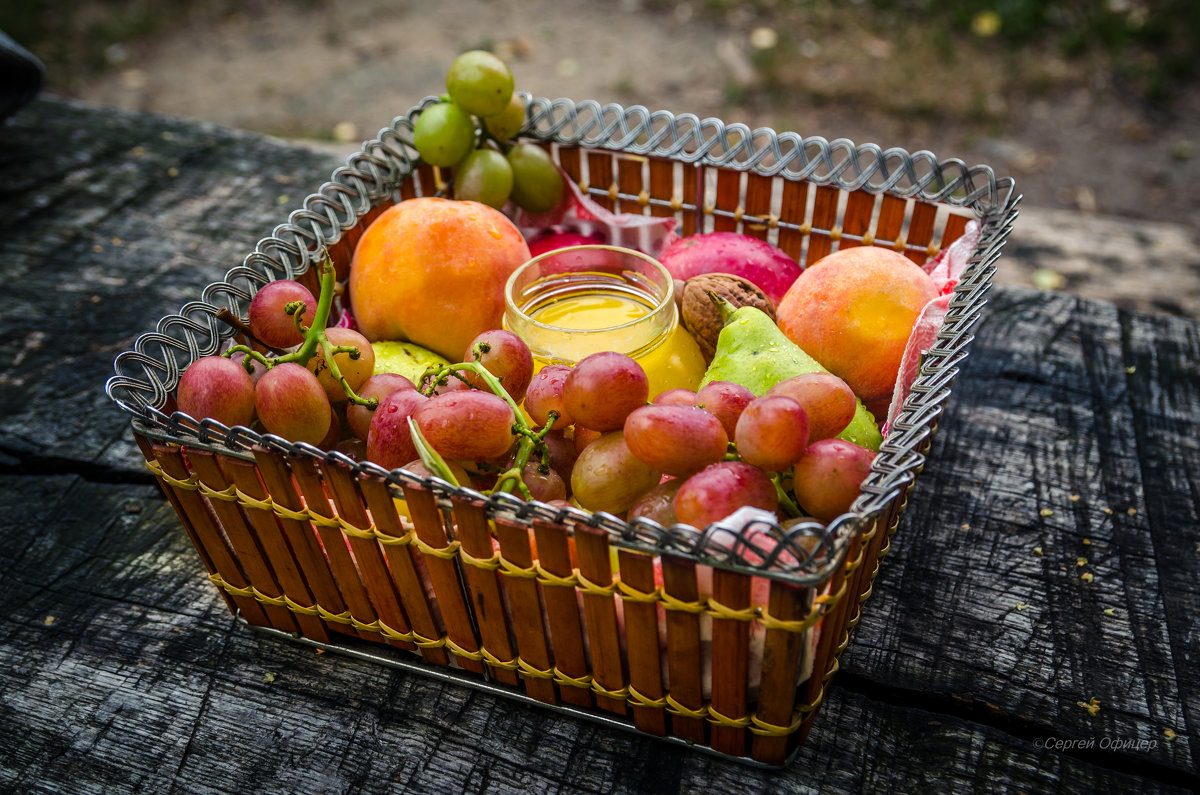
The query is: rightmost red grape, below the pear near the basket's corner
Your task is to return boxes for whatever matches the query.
[792,438,875,522]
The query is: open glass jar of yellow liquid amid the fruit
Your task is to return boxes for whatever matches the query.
[504,245,706,398]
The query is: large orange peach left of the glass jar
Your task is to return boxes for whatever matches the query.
[349,197,529,361]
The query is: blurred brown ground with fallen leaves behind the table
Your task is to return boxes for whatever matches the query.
[7,0,1200,319]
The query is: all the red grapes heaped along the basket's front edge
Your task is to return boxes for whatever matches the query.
[176,289,874,527]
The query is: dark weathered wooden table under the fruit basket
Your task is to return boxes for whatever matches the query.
[0,100,1200,793]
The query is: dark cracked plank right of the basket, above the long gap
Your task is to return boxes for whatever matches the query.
[845,289,1200,770]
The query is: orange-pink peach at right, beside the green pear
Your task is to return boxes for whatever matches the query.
[776,246,937,408]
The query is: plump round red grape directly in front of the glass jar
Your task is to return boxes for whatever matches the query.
[563,351,650,432]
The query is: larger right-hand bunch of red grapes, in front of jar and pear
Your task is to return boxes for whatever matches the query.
[364,330,874,527]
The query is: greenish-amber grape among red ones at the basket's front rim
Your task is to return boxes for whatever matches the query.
[571,431,662,514]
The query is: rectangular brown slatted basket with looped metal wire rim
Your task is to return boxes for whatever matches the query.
[106,97,1019,766]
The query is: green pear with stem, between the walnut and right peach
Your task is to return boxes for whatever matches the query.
[700,294,883,450]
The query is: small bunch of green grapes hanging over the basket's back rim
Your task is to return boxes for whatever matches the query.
[413,49,564,213]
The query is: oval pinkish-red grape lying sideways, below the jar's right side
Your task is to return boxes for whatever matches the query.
[624,405,730,477]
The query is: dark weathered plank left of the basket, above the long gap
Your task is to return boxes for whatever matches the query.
[0,100,340,477]
